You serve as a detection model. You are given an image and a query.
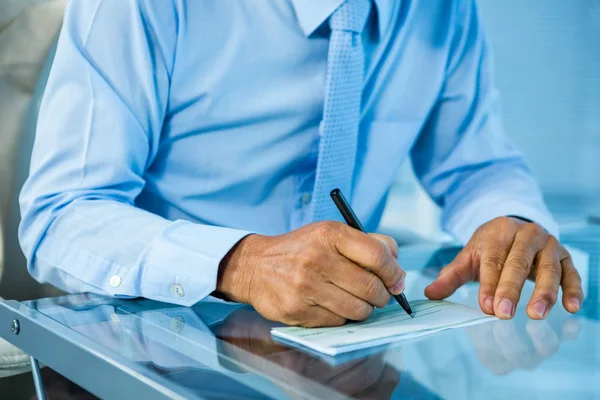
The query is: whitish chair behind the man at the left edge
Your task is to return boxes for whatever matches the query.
[0,0,66,377]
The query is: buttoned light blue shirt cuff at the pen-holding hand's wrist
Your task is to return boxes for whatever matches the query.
[131,221,251,306]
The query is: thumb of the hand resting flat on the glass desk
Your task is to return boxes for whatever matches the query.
[425,248,476,300]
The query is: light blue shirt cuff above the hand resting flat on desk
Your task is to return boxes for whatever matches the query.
[443,201,559,244]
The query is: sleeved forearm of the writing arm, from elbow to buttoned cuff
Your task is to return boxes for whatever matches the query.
[21,199,247,305]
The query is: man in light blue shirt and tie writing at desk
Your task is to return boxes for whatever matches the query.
[20,0,583,326]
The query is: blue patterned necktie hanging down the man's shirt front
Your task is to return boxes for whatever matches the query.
[311,0,372,221]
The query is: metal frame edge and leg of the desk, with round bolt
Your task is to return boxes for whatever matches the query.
[0,300,198,400]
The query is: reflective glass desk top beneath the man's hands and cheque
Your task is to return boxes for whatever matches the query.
[0,225,600,400]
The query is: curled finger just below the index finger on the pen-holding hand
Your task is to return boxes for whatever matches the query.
[323,256,392,308]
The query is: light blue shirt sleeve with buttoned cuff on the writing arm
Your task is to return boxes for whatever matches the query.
[19,0,248,305]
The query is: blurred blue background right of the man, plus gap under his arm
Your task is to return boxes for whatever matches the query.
[382,0,600,237]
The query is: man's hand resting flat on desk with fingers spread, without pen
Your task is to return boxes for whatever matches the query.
[425,217,583,319]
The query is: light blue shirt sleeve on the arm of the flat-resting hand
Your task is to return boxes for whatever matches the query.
[411,0,558,243]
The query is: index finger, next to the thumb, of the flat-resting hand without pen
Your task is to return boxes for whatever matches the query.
[479,229,515,315]
